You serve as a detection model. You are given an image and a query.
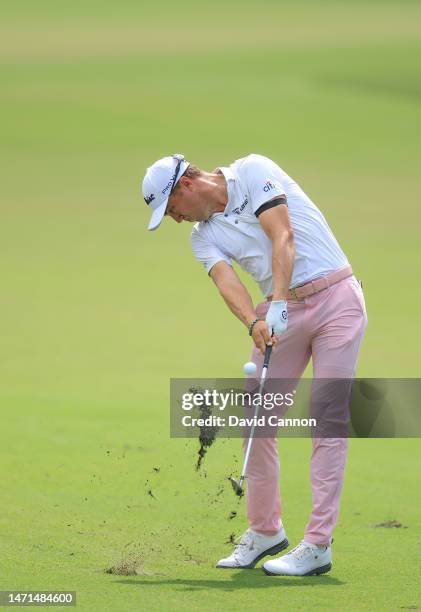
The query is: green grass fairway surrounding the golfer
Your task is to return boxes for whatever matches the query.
[0,0,421,612]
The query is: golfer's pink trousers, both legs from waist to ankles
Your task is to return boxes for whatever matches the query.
[243,276,367,545]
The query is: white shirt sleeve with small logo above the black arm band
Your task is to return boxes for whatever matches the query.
[243,154,287,214]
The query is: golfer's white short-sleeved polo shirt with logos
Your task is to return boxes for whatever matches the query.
[191,154,349,297]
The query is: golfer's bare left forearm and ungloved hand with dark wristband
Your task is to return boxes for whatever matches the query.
[209,261,270,353]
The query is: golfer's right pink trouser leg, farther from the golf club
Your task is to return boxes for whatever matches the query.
[304,277,367,545]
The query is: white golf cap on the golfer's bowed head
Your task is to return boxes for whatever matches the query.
[142,153,189,230]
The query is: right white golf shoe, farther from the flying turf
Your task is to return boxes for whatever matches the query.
[263,540,332,576]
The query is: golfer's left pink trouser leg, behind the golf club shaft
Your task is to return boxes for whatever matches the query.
[243,301,311,534]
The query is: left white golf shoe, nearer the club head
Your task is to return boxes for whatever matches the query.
[216,527,288,569]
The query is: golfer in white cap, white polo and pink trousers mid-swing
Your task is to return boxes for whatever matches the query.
[142,154,367,576]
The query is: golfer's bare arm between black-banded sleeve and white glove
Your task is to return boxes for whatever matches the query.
[259,205,295,301]
